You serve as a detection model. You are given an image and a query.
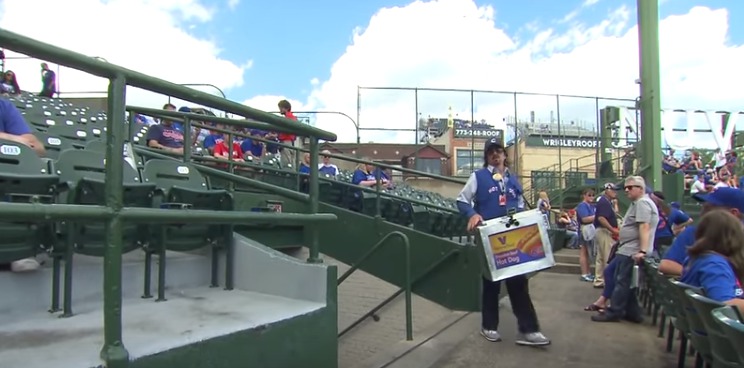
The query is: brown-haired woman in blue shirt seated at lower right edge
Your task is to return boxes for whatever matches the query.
[680,210,744,310]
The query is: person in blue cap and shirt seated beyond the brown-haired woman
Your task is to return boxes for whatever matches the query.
[659,187,744,276]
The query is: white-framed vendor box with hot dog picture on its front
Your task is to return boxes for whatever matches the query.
[477,210,555,281]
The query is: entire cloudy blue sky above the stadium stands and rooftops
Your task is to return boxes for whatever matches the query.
[0,0,744,149]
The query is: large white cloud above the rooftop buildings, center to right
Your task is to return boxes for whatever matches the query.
[248,0,744,150]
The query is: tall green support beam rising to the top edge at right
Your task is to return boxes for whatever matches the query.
[637,0,662,189]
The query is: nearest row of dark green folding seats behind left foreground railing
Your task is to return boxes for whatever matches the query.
[0,141,233,314]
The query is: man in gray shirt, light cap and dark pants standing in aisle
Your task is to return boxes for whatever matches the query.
[592,176,659,323]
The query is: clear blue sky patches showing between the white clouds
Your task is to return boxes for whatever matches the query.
[192,0,744,100]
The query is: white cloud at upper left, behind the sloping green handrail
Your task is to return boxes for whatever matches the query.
[0,0,251,106]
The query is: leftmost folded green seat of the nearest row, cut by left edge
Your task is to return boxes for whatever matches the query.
[0,140,59,274]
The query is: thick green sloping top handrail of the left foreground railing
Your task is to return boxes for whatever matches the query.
[0,29,337,141]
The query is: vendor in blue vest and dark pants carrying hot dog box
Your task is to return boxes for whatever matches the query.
[457,138,550,346]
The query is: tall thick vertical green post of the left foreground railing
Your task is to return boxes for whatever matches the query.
[101,74,129,368]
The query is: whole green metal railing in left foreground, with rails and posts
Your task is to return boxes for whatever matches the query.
[0,29,336,368]
